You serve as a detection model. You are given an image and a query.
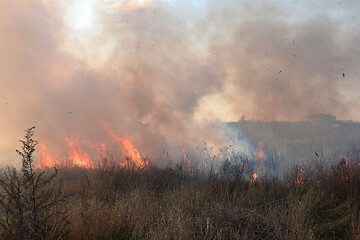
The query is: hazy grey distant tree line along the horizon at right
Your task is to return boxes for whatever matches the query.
[227,113,360,142]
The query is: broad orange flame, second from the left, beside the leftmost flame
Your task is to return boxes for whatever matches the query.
[65,137,96,169]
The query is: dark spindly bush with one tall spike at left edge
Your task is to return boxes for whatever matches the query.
[0,127,69,240]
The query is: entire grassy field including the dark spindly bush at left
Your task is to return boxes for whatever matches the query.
[0,128,360,240]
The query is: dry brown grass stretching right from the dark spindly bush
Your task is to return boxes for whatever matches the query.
[26,153,360,239]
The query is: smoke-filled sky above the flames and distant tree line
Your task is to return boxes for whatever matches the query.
[0,0,360,164]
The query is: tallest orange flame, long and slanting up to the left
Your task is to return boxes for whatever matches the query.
[103,122,146,168]
